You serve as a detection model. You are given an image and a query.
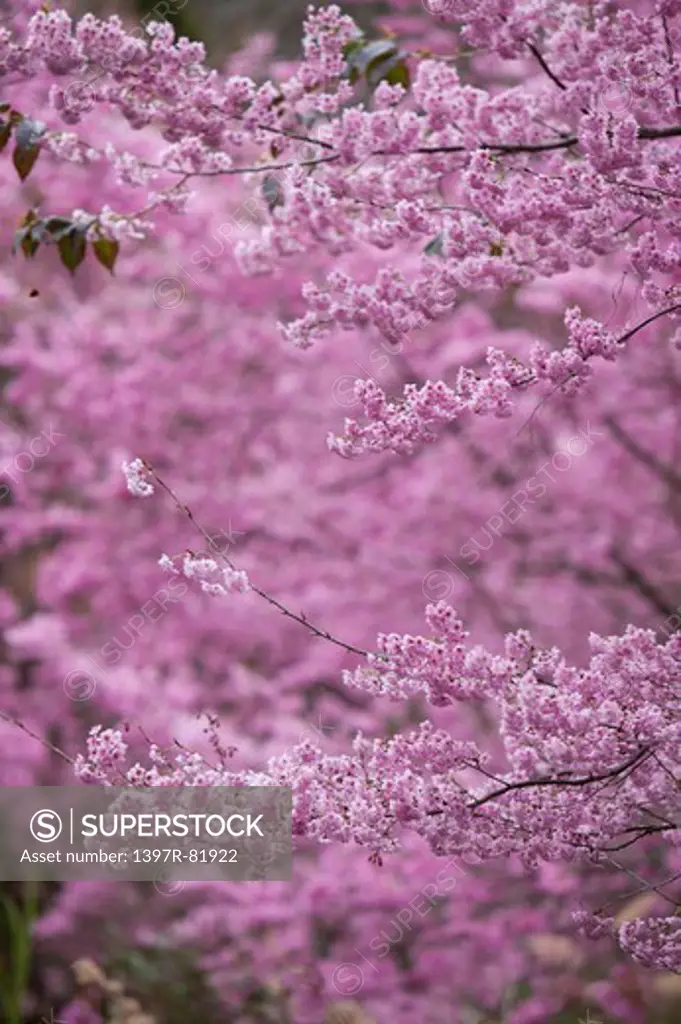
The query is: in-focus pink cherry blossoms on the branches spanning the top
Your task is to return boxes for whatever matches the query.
[3,0,681,456]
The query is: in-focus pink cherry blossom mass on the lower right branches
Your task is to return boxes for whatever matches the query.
[248,603,681,876]
